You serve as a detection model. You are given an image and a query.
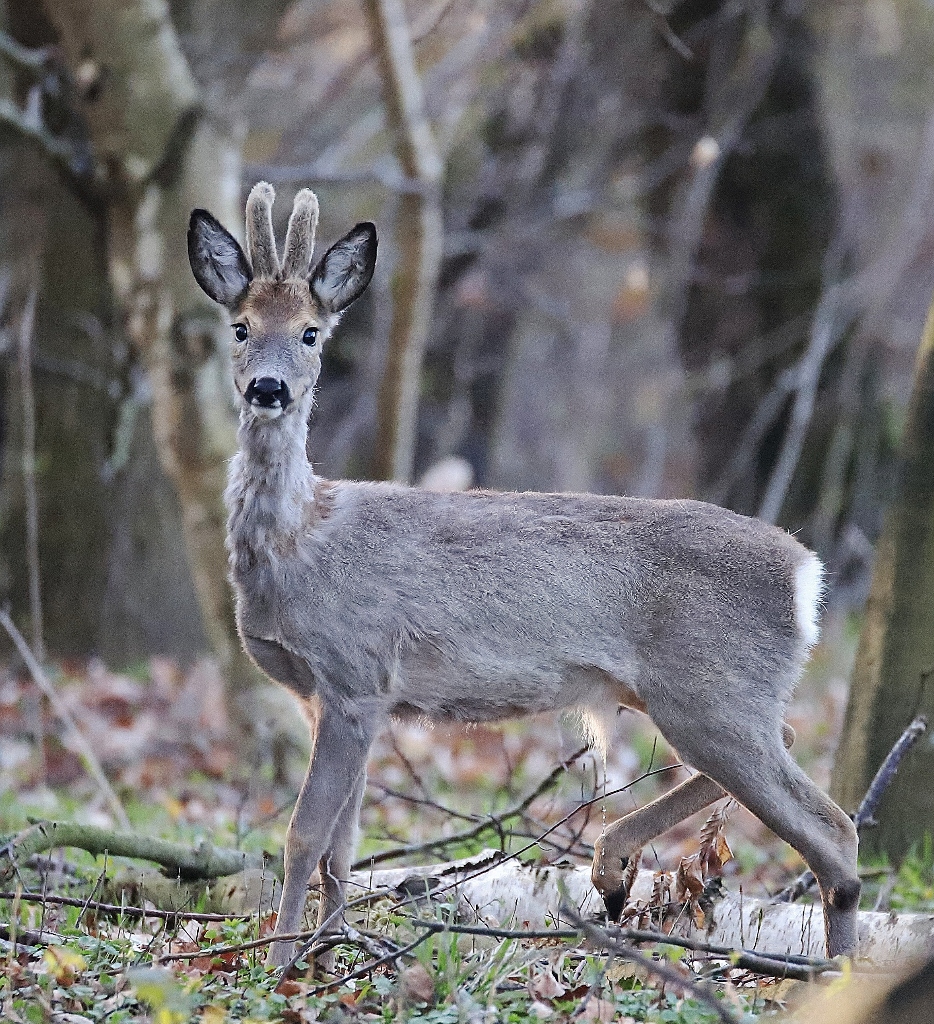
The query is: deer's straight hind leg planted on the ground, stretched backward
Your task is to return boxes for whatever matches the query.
[649,701,860,956]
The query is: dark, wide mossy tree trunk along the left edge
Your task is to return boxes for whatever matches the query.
[0,3,118,654]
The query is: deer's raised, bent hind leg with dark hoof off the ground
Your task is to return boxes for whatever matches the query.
[591,723,795,921]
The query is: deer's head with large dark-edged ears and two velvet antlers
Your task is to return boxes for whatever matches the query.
[188,181,376,420]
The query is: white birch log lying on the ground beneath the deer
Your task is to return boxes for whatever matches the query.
[348,851,934,964]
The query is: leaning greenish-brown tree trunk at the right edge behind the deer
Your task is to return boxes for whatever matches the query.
[832,306,934,861]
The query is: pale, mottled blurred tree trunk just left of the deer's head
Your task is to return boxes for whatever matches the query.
[38,0,254,712]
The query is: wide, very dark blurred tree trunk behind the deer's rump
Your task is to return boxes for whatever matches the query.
[648,0,837,528]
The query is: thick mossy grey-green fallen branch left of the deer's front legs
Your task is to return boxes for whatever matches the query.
[0,821,282,880]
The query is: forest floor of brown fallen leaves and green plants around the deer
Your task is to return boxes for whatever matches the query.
[0,618,934,1024]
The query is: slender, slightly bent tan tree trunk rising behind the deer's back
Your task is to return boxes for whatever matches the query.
[364,0,443,481]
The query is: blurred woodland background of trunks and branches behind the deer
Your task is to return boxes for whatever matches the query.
[0,0,934,855]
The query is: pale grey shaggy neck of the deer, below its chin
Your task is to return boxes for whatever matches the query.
[225,409,327,573]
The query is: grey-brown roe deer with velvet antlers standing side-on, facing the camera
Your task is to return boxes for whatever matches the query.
[188,182,859,965]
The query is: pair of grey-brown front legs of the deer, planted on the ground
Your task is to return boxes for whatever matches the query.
[266,708,375,967]
